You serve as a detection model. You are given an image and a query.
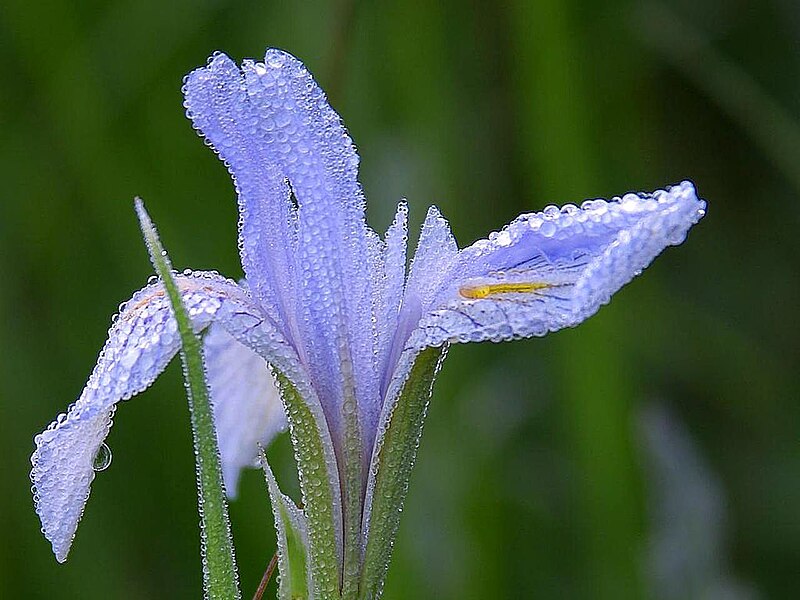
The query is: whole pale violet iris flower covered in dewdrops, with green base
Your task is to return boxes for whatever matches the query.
[31,49,705,597]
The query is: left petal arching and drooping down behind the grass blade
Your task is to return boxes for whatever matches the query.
[31,273,290,562]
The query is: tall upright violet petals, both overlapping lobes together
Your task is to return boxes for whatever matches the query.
[185,50,378,452]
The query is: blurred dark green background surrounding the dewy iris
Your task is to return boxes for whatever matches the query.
[0,0,800,599]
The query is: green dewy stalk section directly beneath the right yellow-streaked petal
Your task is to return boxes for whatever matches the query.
[359,347,445,600]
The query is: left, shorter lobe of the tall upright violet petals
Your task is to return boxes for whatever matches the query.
[183,53,297,337]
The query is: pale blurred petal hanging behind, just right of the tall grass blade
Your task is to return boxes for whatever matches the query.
[203,323,286,497]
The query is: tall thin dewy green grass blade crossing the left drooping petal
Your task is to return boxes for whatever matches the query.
[136,198,241,600]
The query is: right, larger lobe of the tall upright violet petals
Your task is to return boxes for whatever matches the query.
[242,49,377,446]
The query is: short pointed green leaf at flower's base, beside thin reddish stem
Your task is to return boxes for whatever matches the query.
[261,449,310,600]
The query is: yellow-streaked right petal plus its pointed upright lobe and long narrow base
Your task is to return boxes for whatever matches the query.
[362,182,705,572]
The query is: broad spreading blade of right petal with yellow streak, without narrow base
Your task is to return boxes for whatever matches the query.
[408,182,705,348]
